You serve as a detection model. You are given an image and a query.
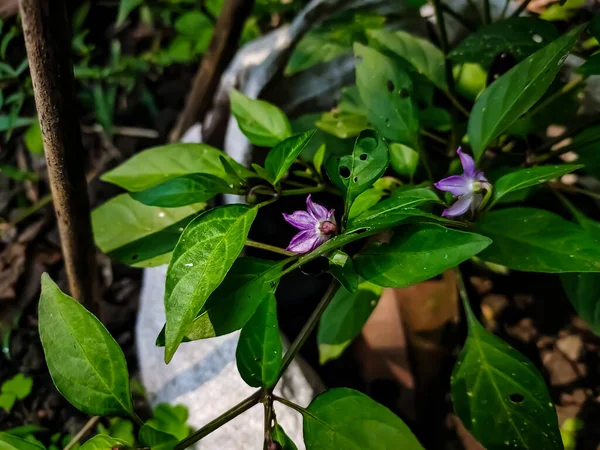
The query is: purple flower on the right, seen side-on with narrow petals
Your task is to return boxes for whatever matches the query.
[434,148,491,217]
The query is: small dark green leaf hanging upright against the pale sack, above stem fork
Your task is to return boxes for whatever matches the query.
[235,294,282,388]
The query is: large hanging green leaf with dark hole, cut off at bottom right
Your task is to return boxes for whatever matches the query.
[451,305,563,450]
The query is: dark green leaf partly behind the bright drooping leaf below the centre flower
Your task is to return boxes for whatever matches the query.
[157,257,283,345]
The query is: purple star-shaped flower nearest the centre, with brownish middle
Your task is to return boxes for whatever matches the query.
[283,195,337,253]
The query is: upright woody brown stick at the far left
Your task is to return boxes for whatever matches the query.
[20,0,99,311]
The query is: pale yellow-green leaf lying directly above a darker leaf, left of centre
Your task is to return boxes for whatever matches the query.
[101,144,252,191]
